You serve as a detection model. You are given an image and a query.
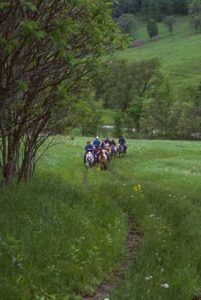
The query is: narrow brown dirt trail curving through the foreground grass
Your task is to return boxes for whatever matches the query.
[82,219,141,300]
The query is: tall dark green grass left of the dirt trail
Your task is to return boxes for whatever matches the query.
[0,157,126,300]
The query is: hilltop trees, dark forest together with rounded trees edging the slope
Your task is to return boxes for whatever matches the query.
[113,0,201,38]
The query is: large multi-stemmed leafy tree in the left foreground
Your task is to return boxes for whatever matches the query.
[0,0,119,182]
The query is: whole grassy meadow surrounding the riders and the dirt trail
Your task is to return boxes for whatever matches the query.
[0,138,201,300]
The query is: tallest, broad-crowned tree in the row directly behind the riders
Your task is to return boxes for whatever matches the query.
[96,59,162,131]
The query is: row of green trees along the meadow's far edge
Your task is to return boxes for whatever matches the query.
[93,58,201,139]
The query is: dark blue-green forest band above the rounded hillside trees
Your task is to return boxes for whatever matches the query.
[112,0,191,21]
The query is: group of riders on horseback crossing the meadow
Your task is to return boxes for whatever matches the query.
[84,136,127,170]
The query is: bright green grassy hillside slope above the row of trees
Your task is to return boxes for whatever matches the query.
[117,17,201,86]
